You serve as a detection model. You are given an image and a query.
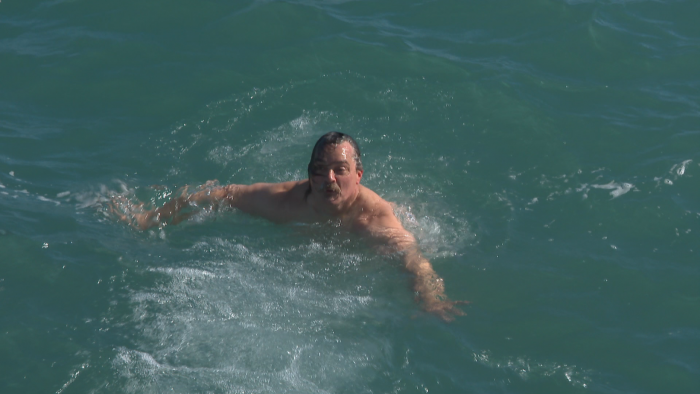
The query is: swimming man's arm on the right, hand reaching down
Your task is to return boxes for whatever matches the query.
[363,203,467,321]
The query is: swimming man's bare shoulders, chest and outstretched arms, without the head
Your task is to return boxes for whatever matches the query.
[115,180,464,321]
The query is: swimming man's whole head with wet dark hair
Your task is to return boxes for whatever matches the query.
[308,131,363,210]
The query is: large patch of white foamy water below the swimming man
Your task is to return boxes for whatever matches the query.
[113,237,394,393]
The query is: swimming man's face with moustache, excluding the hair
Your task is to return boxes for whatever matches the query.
[310,142,362,207]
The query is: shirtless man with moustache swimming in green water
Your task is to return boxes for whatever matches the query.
[113,132,464,321]
